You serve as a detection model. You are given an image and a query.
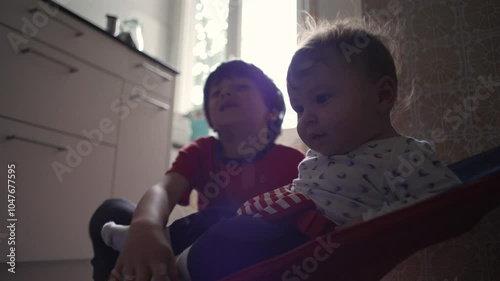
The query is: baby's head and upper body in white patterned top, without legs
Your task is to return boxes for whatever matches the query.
[238,20,461,231]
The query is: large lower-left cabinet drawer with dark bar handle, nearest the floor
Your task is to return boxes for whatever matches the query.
[0,118,115,261]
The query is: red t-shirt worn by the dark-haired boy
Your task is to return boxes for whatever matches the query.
[167,137,304,210]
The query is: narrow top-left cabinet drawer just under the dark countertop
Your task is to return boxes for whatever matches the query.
[0,0,129,77]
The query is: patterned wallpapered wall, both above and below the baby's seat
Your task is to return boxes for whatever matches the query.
[362,0,500,281]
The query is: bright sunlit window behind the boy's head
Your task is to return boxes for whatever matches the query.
[176,0,297,128]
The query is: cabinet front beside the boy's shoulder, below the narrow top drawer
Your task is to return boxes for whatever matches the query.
[113,84,172,203]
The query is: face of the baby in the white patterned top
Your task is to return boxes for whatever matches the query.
[288,52,379,155]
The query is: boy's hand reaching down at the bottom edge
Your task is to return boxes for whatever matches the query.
[109,222,179,281]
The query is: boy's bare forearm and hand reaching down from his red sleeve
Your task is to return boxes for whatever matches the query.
[110,172,189,281]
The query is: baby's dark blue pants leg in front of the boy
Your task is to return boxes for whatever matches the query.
[187,216,310,281]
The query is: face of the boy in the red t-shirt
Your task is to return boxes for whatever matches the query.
[208,77,269,131]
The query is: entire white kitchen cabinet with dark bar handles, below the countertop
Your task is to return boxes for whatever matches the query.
[0,0,177,262]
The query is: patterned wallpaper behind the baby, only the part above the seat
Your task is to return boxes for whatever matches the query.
[363,0,500,164]
